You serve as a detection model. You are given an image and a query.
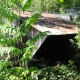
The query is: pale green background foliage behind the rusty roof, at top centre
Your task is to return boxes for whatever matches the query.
[30,0,59,13]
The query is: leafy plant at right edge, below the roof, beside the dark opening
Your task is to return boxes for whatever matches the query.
[71,29,80,70]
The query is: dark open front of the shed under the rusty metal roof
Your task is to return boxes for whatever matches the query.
[32,34,75,68]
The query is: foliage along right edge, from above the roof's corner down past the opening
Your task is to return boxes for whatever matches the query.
[70,16,80,71]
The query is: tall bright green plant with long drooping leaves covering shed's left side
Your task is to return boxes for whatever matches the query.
[0,0,47,80]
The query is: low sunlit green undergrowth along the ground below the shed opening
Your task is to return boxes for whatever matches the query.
[0,61,80,80]
